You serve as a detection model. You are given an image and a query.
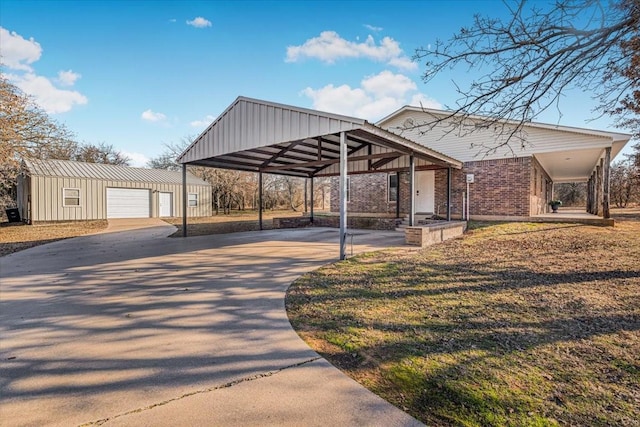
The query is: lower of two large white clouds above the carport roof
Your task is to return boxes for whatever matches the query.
[301,70,442,121]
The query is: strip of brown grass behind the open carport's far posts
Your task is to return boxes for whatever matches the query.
[163,211,302,237]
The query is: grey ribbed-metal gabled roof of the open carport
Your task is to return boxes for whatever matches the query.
[178,96,462,177]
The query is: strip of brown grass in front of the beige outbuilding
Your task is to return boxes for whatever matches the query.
[0,220,107,256]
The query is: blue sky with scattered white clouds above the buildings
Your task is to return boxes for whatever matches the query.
[0,0,629,166]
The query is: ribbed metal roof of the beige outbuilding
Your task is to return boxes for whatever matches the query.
[23,159,211,186]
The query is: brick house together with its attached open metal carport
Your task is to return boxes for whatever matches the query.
[178,96,630,259]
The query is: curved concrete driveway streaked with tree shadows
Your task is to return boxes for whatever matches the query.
[0,221,419,426]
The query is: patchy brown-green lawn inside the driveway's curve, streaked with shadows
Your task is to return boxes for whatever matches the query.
[286,210,640,426]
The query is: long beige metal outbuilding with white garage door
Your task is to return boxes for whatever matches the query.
[18,159,211,223]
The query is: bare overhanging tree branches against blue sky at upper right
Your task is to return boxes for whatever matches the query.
[412,0,640,152]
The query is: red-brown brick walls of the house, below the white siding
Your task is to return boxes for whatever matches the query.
[331,157,536,218]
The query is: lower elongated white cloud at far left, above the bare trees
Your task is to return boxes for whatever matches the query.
[7,73,88,114]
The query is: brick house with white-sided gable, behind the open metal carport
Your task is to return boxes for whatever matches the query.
[331,106,630,219]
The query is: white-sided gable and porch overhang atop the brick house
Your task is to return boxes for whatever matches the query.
[377,106,631,183]
